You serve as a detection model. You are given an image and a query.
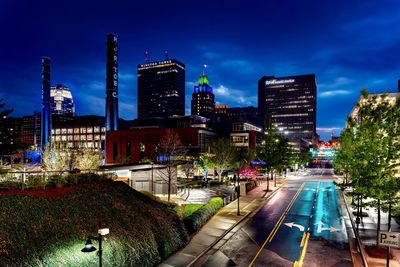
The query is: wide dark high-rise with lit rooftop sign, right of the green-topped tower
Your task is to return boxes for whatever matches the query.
[258,74,317,141]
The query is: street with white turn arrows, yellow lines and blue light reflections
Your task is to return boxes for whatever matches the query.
[198,169,347,266]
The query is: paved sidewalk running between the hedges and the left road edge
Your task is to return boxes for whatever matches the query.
[159,179,283,267]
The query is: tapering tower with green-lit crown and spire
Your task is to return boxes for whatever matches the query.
[192,73,215,120]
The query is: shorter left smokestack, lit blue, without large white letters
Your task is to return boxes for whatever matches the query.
[40,57,51,151]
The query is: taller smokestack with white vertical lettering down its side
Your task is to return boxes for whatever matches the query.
[106,34,118,131]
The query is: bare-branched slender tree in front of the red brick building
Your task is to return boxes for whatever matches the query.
[157,129,186,202]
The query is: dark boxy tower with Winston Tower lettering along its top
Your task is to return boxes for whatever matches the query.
[138,59,185,119]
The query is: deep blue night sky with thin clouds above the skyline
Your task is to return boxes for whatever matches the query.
[0,0,400,139]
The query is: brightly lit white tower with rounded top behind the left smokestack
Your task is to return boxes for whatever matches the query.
[50,84,75,116]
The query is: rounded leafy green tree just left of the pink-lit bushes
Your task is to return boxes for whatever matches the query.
[210,138,236,182]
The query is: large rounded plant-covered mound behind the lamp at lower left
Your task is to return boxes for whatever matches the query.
[0,182,188,267]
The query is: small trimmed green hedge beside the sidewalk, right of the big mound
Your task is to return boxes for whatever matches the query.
[183,197,224,234]
